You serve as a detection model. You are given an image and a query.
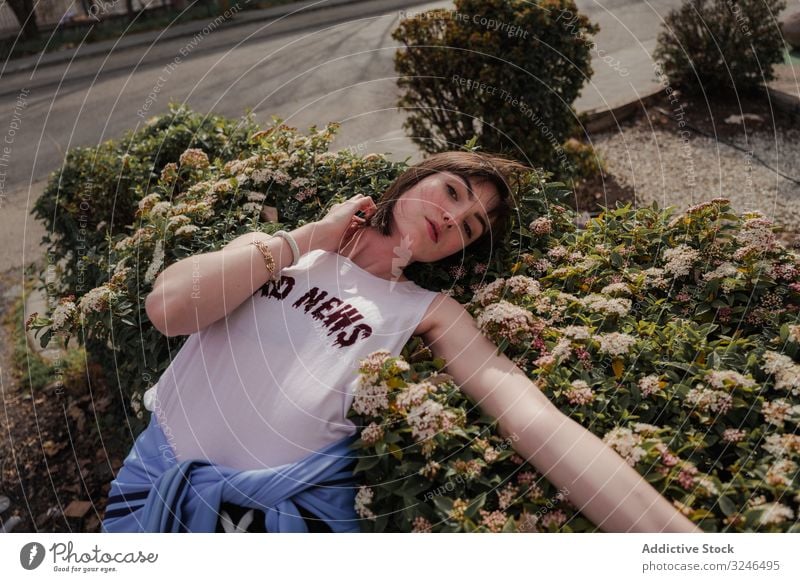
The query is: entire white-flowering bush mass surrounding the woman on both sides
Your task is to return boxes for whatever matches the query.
[30,106,800,531]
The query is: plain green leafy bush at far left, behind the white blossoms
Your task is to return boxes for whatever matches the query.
[33,102,257,294]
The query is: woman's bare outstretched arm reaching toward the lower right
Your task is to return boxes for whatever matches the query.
[423,296,702,533]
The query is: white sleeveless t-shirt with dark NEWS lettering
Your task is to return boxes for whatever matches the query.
[145,249,437,470]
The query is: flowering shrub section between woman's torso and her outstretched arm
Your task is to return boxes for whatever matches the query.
[351,338,580,532]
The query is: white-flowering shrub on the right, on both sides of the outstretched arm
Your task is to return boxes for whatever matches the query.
[351,199,800,532]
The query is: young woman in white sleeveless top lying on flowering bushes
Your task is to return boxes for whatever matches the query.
[103,152,700,532]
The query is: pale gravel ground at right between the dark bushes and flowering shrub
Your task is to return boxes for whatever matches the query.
[593,118,800,240]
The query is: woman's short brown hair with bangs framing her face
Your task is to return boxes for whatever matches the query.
[369,151,533,252]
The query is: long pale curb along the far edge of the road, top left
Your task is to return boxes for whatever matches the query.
[6,0,416,75]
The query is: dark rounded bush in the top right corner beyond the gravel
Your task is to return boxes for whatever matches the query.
[654,0,786,93]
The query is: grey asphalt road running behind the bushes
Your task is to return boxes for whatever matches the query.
[0,0,680,270]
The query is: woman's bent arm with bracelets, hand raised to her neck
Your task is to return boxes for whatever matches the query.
[145,194,375,337]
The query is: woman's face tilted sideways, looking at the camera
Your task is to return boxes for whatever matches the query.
[392,172,500,263]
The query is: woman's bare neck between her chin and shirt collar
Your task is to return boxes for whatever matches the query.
[338,226,410,280]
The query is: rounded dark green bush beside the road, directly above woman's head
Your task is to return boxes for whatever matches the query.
[392,0,599,179]
